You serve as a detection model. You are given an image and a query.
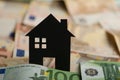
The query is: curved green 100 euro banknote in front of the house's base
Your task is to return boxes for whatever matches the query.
[0,64,80,80]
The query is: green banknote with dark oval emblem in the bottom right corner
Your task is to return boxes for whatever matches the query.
[81,61,120,80]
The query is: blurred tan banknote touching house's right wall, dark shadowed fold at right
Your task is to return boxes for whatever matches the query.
[71,24,119,58]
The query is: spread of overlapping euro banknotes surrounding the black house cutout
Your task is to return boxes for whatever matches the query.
[0,0,120,80]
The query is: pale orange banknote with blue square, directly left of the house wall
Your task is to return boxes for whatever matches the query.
[13,23,32,58]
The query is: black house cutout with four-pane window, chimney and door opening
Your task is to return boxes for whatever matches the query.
[26,14,74,71]
